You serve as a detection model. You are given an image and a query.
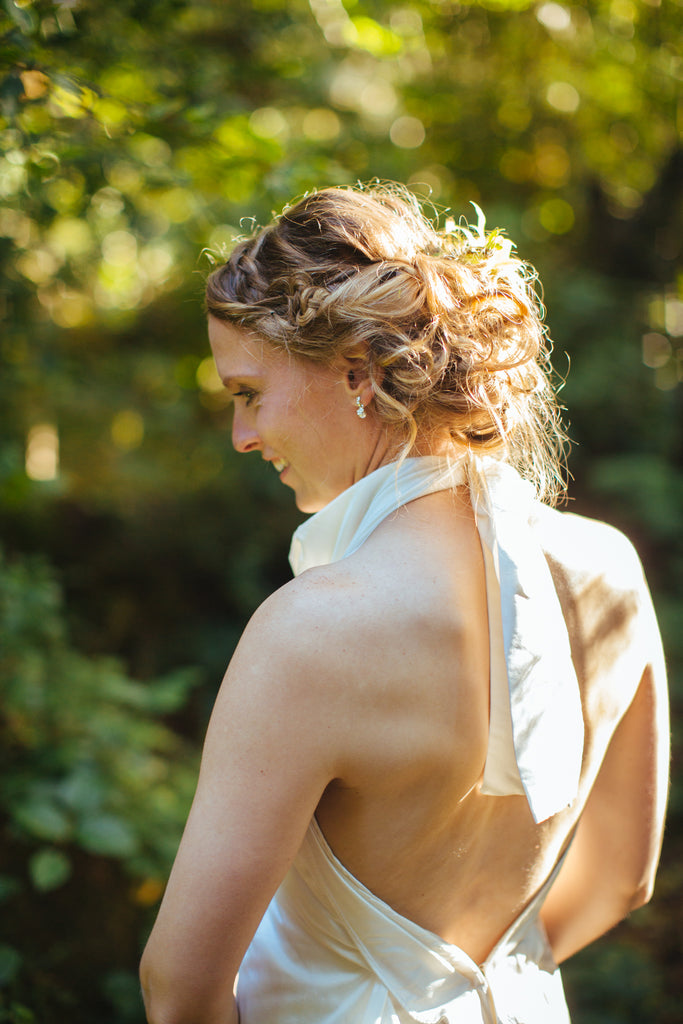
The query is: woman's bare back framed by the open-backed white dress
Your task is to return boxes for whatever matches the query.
[313,493,656,962]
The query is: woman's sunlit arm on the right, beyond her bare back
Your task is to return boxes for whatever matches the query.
[541,595,669,963]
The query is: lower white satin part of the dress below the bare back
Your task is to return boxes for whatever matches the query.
[238,819,569,1024]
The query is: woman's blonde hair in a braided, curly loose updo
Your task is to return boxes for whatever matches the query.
[206,185,566,502]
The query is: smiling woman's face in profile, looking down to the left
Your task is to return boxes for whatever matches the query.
[209,316,386,512]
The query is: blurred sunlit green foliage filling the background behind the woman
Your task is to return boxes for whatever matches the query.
[0,0,683,1024]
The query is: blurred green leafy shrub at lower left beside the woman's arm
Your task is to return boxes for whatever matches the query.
[0,544,198,1021]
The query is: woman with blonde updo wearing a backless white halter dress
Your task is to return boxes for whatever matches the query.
[141,188,668,1024]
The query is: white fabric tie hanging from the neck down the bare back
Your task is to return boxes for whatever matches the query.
[469,458,584,822]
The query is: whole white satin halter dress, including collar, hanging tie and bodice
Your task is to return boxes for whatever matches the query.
[238,457,583,1024]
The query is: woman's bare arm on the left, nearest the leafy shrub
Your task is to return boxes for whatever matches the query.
[140,582,350,1024]
